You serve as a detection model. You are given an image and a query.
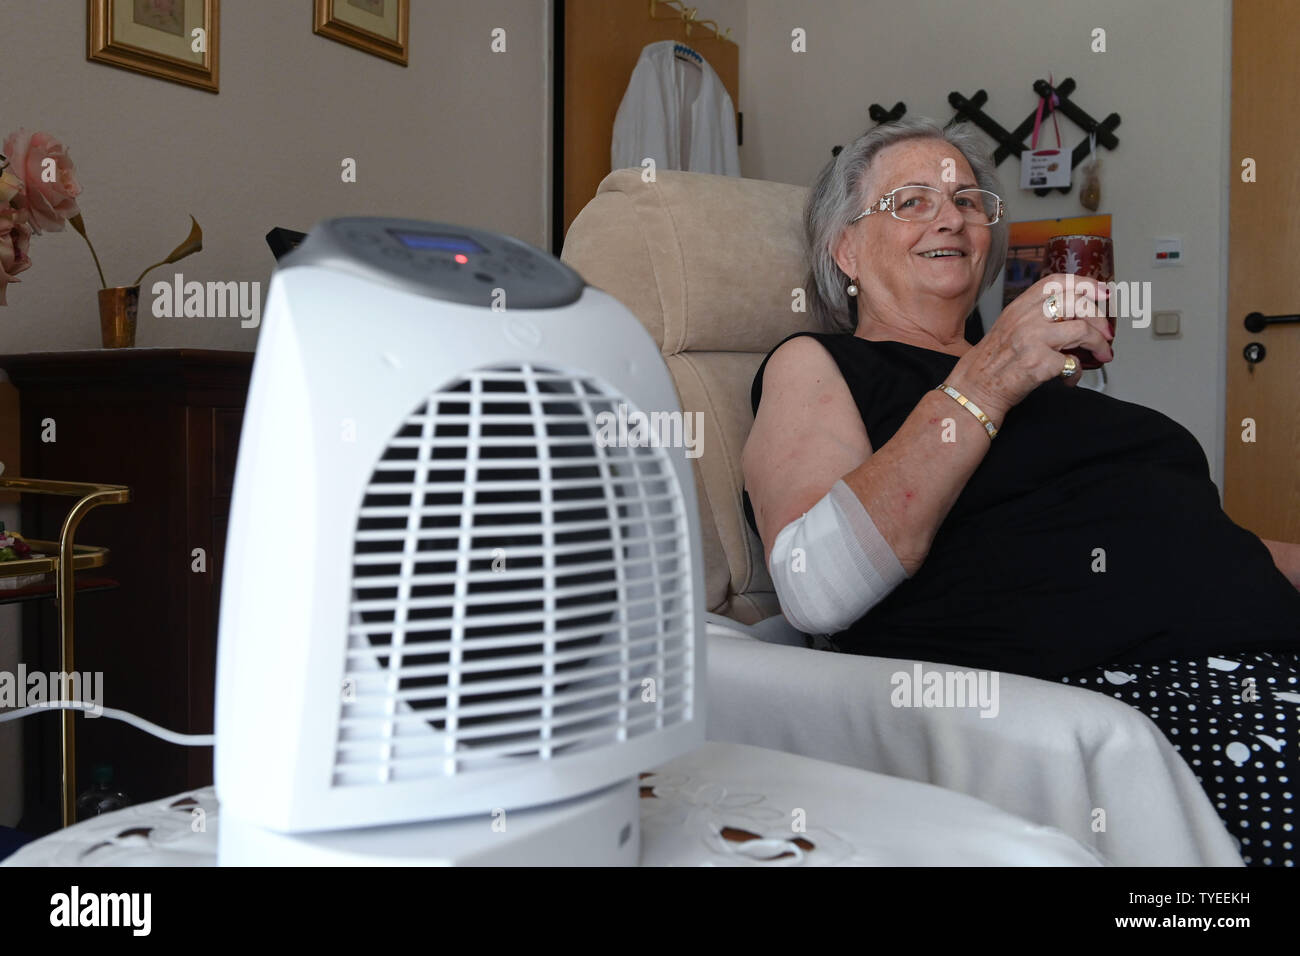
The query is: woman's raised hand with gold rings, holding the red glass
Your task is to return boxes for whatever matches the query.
[948,274,1114,424]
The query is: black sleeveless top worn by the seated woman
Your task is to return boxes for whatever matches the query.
[745,332,1300,678]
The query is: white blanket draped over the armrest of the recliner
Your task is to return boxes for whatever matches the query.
[707,632,1243,866]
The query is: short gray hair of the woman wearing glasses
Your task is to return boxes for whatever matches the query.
[803,117,1008,333]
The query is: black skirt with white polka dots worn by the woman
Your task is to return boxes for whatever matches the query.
[1061,650,1300,866]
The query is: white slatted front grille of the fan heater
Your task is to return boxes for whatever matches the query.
[334,364,696,786]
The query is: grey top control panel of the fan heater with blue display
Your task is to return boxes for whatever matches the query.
[288,217,586,310]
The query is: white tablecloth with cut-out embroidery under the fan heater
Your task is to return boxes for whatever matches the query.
[3,741,1105,866]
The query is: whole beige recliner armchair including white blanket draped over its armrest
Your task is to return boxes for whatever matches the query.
[562,169,1242,866]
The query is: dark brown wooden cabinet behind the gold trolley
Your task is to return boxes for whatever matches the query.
[0,349,252,832]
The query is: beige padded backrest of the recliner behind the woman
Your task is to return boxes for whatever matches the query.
[563,170,814,624]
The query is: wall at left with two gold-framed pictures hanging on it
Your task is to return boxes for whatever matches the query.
[0,0,550,354]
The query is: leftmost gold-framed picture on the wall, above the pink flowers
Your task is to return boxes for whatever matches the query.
[86,0,221,92]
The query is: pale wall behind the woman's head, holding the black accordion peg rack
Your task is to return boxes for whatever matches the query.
[741,0,1231,481]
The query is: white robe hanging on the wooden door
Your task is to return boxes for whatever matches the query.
[610,40,740,176]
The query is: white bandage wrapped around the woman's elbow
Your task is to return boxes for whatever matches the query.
[767,479,907,633]
